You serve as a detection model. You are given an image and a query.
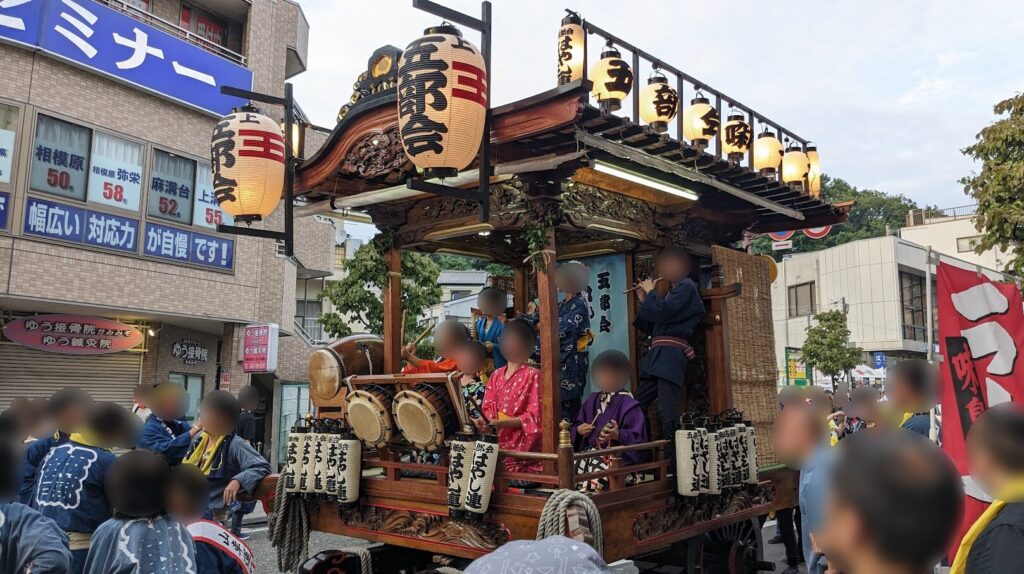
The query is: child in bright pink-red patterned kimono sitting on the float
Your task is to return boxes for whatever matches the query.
[481,319,541,473]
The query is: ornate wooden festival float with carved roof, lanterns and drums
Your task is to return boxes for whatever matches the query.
[239,0,849,574]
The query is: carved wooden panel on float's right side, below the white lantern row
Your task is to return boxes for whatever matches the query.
[633,482,775,542]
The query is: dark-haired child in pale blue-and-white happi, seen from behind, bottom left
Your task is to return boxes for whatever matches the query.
[85,450,196,574]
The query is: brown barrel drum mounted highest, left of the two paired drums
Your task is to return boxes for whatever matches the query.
[308,334,384,401]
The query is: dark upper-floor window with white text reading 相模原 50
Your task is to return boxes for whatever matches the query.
[30,115,92,202]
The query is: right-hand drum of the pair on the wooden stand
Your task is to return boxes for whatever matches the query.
[391,383,459,450]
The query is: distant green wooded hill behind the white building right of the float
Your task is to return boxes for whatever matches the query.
[752,175,932,256]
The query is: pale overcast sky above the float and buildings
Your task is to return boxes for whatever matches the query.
[293,0,1024,216]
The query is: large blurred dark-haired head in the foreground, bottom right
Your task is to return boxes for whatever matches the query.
[817,431,964,572]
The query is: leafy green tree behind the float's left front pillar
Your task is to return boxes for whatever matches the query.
[321,235,441,339]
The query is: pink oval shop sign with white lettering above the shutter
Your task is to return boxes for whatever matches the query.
[3,314,143,355]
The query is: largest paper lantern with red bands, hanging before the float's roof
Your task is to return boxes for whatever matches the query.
[398,24,487,178]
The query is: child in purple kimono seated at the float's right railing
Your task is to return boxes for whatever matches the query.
[572,350,647,465]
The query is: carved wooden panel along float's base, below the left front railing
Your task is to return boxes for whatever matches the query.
[341,506,509,550]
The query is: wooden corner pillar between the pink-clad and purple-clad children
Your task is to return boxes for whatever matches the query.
[537,230,562,453]
